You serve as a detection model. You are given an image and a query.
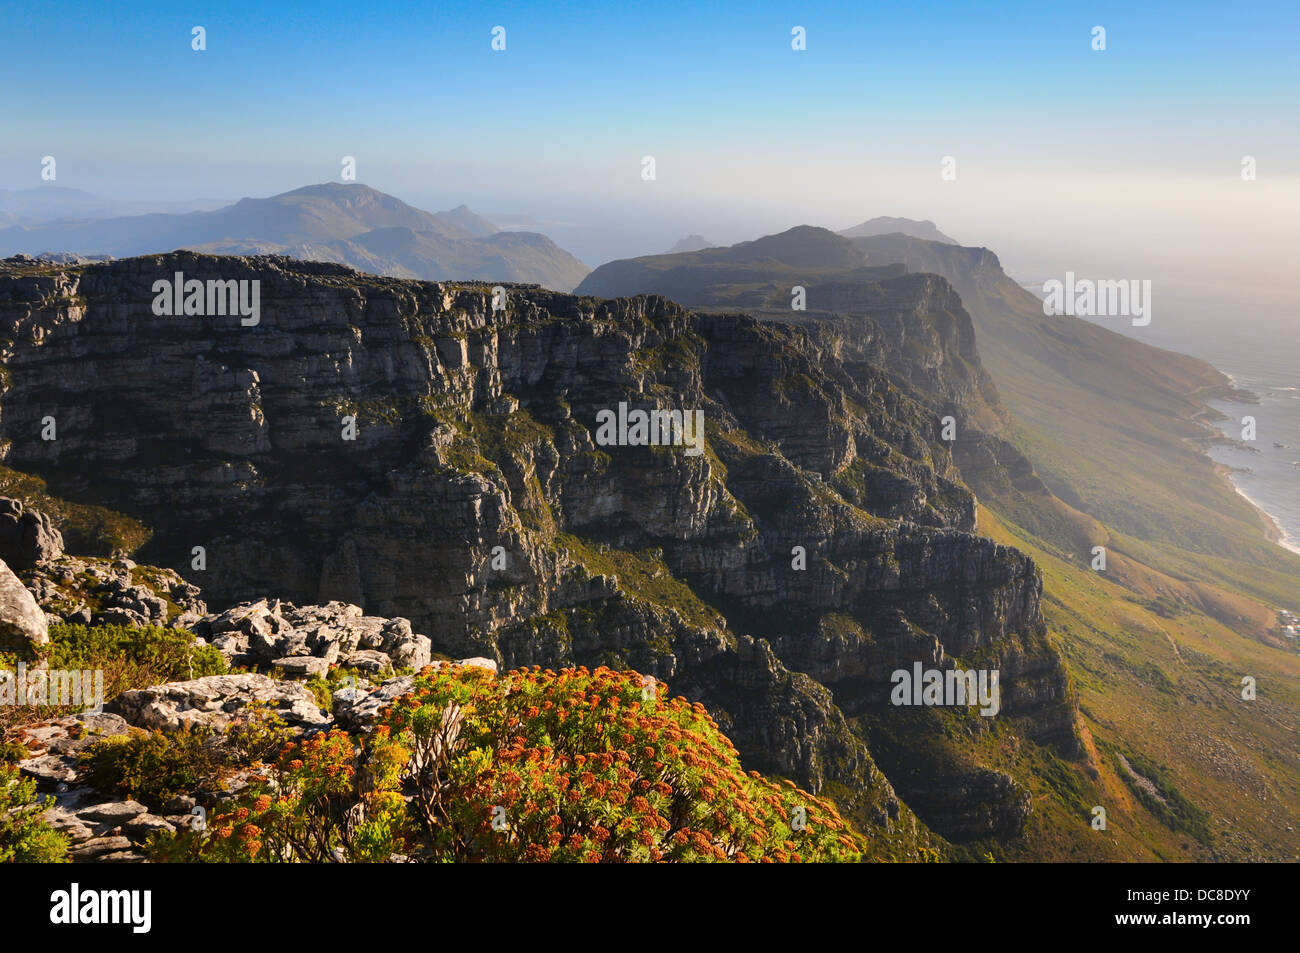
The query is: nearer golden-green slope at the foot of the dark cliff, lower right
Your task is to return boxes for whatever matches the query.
[979,506,1300,861]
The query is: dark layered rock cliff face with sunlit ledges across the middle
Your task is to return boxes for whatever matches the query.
[0,252,1074,837]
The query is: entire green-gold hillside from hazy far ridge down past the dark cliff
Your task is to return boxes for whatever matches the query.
[586,229,1300,861]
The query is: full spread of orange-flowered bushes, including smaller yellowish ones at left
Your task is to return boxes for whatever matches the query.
[157,666,862,862]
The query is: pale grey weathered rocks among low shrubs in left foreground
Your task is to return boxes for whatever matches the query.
[0,498,497,862]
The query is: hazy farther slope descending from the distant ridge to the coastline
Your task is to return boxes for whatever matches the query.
[854,235,1300,606]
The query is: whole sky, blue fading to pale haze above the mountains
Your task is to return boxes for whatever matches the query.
[0,1,1300,282]
